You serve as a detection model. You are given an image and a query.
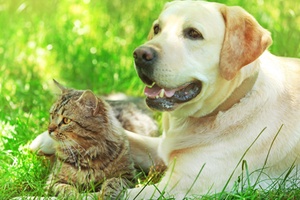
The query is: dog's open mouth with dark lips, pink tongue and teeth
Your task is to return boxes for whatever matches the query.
[144,81,202,111]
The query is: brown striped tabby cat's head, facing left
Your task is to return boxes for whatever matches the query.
[48,80,111,146]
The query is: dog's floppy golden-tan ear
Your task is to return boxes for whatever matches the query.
[220,6,272,80]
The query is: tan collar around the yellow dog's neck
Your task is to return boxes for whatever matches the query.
[208,72,258,116]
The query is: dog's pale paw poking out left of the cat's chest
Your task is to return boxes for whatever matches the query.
[29,131,55,155]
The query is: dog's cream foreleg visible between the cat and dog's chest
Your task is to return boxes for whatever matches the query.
[125,130,163,172]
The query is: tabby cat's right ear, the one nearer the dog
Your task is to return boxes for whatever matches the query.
[76,90,98,115]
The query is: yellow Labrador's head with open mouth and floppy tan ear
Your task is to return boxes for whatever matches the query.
[134,1,272,116]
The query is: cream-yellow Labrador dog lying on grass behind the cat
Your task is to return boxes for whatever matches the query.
[32,1,300,199]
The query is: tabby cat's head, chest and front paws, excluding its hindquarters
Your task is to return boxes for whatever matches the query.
[46,81,135,199]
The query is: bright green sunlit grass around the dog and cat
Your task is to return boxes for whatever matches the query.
[0,0,300,199]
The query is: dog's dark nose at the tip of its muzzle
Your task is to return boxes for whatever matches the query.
[133,46,157,67]
